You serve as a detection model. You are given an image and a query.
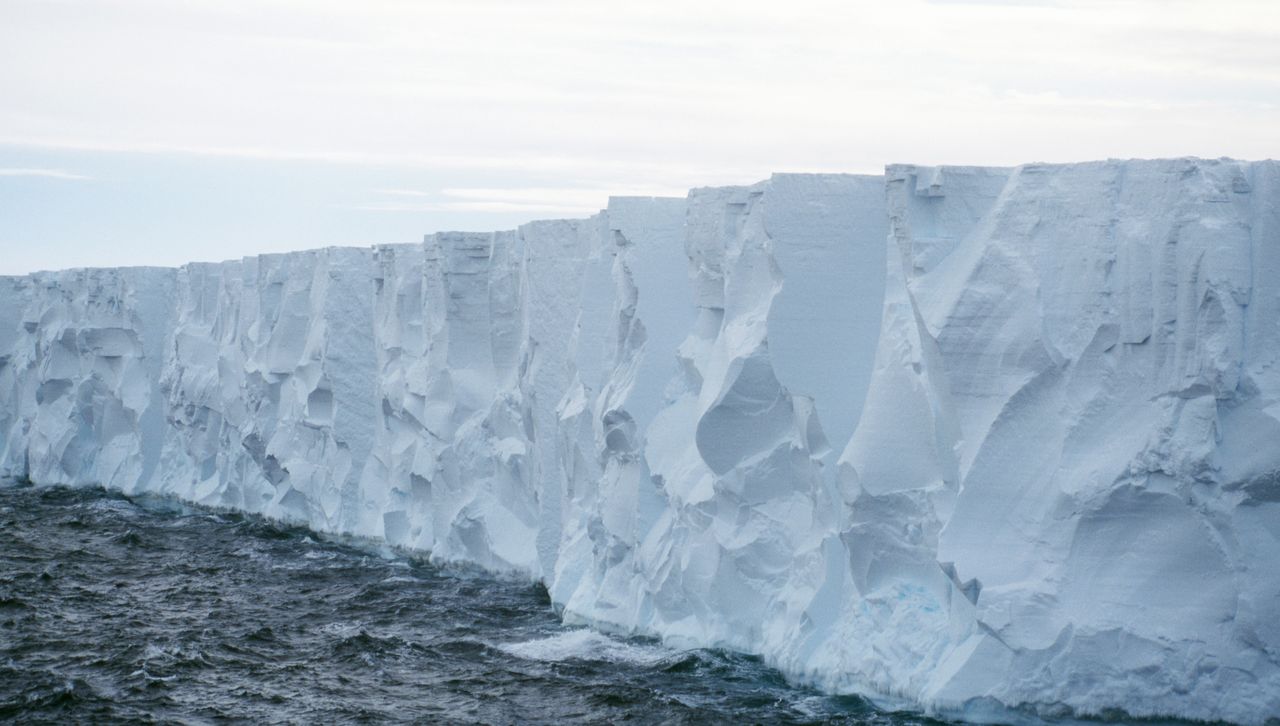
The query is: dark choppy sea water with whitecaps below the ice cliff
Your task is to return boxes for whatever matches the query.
[0,483,931,725]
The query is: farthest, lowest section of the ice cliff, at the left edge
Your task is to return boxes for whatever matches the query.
[0,268,175,492]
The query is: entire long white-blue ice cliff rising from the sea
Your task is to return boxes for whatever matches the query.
[0,159,1280,723]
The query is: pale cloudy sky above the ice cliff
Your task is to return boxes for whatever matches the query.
[0,0,1280,274]
